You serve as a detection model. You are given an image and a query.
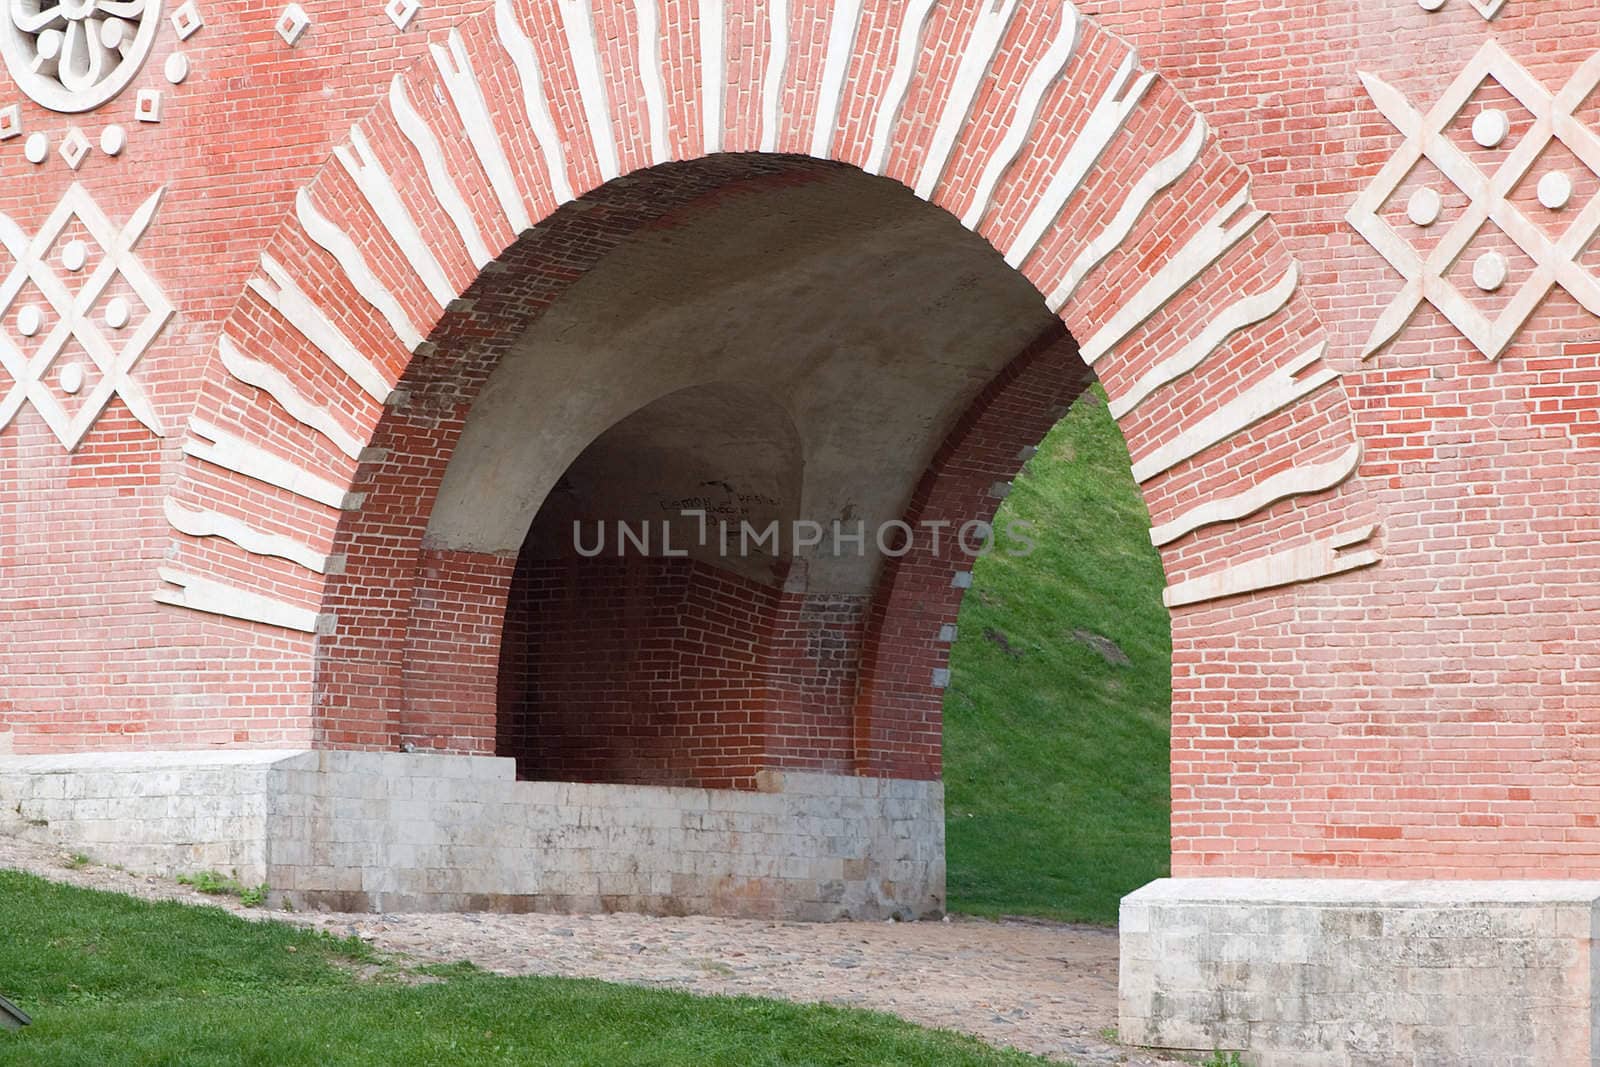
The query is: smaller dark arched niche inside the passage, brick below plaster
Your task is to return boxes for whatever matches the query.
[494,384,803,785]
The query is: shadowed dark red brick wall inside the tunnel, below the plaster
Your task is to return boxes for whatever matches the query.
[496,553,866,789]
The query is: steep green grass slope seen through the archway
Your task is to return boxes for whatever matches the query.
[944,386,1171,923]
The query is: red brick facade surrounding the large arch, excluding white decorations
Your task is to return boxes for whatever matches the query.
[0,0,1600,877]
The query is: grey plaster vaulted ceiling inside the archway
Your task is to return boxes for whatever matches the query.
[429,168,1056,592]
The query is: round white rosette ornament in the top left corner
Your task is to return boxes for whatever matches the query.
[0,0,162,112]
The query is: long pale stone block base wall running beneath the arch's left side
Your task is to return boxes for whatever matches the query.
[0,750,944,920]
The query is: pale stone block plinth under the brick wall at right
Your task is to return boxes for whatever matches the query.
[1118,878,1600,1067]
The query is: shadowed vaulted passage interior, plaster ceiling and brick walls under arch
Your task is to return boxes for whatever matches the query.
[411,157,1068,789]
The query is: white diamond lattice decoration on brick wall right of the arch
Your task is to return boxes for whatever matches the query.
[1346,40,1600,360]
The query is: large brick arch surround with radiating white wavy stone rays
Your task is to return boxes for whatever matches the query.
[157,0,1378,780]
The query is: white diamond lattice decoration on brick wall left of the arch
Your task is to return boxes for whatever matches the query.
[0,184,173,451]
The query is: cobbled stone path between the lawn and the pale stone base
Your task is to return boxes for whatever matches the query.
[0,837,1189,1067]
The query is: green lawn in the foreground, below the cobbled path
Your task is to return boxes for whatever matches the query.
[0,870,1043,1067]
